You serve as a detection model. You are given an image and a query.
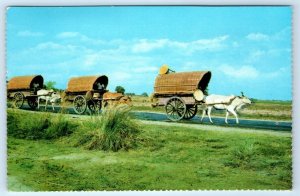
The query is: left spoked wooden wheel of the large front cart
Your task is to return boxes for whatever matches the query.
[165,97,186,121]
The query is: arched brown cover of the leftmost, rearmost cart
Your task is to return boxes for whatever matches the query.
[7,75,44,90]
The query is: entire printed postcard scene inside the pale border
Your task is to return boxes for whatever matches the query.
[6,6,293,192]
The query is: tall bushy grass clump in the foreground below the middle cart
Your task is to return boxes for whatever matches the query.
[79,105,141,151]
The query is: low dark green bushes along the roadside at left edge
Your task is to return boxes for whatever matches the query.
[7,110,76,139]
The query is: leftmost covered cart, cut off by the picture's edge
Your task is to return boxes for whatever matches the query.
[7,75,44,109]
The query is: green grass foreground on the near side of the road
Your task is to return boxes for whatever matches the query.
[7,109,292,191]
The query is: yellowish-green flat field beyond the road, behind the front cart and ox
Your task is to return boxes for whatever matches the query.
[132,96,292,121]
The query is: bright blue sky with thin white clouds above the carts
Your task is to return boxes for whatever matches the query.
[6,6,292,100]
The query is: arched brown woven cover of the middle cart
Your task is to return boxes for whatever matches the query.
[66,75,108,92]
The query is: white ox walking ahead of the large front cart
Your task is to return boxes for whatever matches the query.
[201,93,251,124]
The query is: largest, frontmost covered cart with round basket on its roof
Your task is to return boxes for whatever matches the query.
[152,67,211,121]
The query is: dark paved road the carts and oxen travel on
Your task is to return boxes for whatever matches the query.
[12,105,292,131]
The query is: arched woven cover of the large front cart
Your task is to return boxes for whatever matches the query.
[154,71,211,95]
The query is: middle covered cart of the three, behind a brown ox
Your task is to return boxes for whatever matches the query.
[63,75,108,114]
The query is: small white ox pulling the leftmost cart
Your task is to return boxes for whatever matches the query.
[37,89,61,111]
